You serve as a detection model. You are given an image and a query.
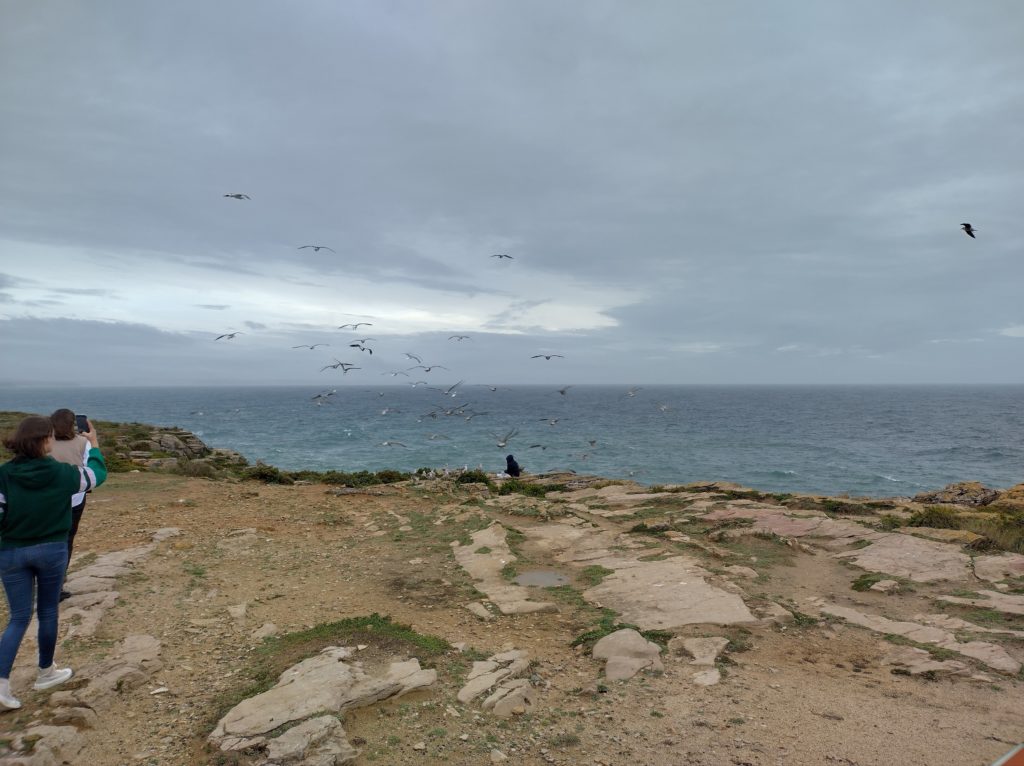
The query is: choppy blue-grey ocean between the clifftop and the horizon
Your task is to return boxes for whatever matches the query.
[0,385,1024,497]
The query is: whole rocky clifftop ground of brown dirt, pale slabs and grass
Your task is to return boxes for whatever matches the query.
[0,472,1024,766]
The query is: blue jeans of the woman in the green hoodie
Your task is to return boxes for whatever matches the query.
[0,541,68,678]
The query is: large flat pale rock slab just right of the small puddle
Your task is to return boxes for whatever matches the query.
[583,556,757,630]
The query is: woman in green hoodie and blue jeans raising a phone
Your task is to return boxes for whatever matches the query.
[0,416,106,710]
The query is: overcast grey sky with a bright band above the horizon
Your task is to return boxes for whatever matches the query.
[0,0,1024,386]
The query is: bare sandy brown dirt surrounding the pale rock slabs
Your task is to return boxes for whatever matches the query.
[0,473,1024,766]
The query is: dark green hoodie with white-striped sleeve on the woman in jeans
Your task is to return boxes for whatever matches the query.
[0,448,106,550]
